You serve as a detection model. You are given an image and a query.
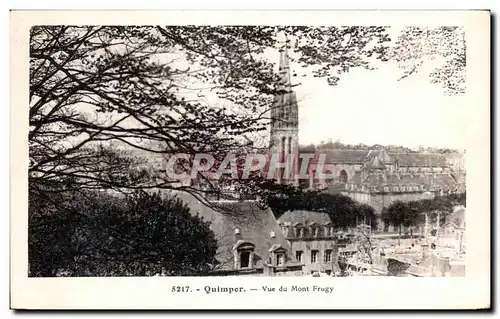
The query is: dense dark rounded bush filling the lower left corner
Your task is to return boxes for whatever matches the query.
[28,192,217,276]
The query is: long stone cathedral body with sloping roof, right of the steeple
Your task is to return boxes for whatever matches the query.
[302,149,466,231]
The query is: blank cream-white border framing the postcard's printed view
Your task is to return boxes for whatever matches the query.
[11,11,490,309]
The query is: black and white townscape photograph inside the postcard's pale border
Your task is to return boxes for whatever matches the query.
[9,9,489,310]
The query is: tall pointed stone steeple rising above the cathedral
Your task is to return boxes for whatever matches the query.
[269,39,299,186]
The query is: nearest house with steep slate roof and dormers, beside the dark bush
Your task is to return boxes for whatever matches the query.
[178,194,303,276]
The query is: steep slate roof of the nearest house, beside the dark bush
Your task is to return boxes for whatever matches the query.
[174,193,299,270]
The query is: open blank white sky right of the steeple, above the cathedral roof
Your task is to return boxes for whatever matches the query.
[296,57,467,149]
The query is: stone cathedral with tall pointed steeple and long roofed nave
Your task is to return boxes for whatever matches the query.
[270,47,466,230]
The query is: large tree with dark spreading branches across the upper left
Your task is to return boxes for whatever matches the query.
[29,26,389,205]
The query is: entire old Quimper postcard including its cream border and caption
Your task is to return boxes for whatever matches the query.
[10,10,491,310]
